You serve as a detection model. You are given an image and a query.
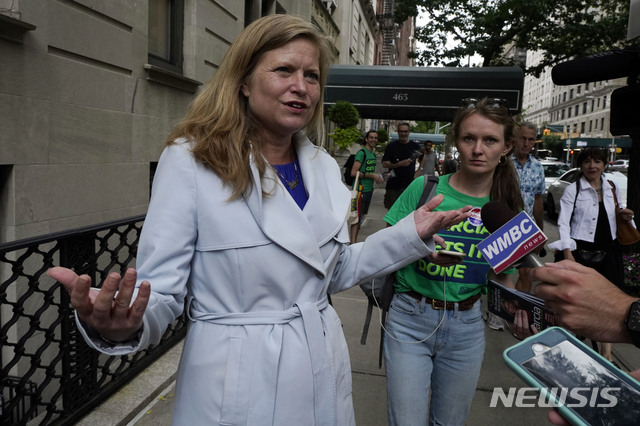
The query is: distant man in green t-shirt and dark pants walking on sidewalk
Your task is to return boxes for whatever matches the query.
[349,130,384,244]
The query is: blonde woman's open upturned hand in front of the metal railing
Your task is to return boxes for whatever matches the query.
[48,266,151,342]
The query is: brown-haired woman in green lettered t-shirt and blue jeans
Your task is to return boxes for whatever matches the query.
[384,98,522,426]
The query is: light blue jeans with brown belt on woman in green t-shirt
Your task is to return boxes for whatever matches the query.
[384,293,485,426]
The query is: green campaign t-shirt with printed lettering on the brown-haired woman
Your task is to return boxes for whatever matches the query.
[384,175,490,302]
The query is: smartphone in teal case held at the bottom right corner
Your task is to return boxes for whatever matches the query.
[503,327,640,425]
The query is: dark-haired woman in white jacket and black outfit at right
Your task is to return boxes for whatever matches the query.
[549,147,633,360]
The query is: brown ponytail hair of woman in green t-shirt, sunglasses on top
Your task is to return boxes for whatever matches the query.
[451,98,524,211]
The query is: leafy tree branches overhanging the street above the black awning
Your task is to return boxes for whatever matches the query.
[394,0,630,76]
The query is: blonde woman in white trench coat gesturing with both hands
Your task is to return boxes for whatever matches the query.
[50,15,469,426]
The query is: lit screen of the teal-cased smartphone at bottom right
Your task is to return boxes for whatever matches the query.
[521,340,640,425]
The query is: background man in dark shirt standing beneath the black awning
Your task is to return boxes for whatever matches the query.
[382,123,422,209]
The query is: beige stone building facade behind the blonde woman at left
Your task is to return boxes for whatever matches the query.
[0,0,377,242]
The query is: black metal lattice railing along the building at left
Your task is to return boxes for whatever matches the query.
[0,216,187,425]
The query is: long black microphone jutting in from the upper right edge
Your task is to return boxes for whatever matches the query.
[551,49,640,86]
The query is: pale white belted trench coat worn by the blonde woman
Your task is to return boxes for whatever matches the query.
[80,135,433,426]
